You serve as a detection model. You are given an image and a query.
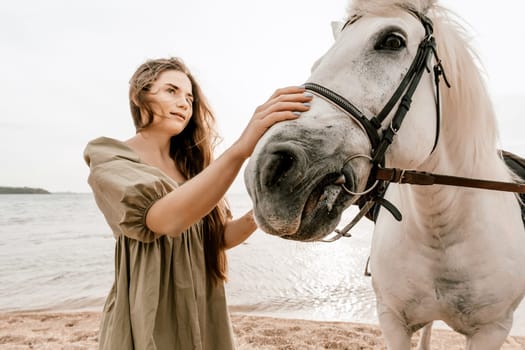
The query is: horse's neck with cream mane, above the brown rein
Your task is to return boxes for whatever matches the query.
[424,9,508,181]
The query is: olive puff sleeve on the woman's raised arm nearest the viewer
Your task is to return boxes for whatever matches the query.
[84,138,177,242]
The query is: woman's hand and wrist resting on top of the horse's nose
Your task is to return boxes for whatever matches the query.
[232,86,312,158]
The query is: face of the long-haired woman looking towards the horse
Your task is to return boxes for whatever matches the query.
[142,70,193,136]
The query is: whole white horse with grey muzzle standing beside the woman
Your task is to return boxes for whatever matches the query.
[245,0,525,350]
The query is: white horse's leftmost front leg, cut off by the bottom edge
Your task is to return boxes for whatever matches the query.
[377,305,412,350]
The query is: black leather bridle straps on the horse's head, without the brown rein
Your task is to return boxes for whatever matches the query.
[304,10,450,241]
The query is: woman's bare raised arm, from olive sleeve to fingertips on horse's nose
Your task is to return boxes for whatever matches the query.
[146,87,311,236]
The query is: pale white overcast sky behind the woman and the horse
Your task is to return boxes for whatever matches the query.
[0,0,525,192]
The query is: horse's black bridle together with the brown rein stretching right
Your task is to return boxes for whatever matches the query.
[304,9,525,242]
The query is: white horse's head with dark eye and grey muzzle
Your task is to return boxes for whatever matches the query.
[245,1,442,241]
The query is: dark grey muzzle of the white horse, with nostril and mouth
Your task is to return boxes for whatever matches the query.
[245,137,366,241]
